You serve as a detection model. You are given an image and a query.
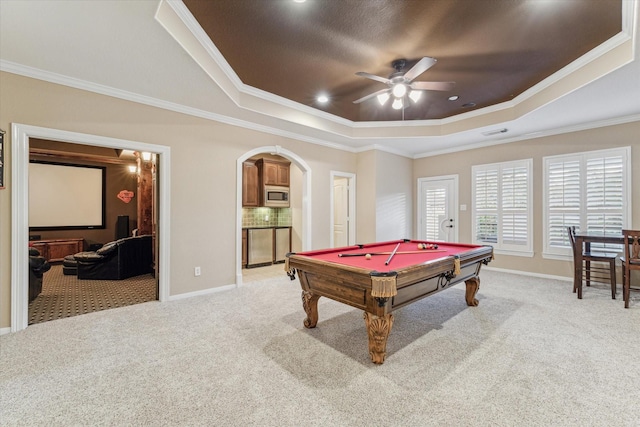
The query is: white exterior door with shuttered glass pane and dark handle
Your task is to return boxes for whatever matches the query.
[418,175,458,242]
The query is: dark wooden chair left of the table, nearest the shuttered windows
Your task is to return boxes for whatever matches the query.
[567,227,617,299]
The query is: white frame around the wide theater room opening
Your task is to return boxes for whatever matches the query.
[11,123,171,332]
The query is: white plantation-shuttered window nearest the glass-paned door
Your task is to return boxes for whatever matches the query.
[472,159,533,256]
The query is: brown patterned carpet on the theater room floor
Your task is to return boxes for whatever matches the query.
[29,264,158,325]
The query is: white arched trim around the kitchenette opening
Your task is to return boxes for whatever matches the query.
[236,145,311,286]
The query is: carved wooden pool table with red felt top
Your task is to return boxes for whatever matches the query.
[285,239,493,364]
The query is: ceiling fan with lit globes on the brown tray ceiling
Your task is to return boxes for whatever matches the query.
[353,56,455,110]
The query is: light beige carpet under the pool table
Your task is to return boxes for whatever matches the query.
[0,270,640,426]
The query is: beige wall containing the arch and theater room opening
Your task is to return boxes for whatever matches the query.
[0,73,357,328]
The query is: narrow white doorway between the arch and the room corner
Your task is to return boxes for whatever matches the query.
[330,171,356,248]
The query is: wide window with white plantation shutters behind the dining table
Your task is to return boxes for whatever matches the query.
[543,147,631,258]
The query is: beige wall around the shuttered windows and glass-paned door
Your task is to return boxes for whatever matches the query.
[414,122,640,277]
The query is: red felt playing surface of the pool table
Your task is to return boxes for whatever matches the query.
[296,240,482,273]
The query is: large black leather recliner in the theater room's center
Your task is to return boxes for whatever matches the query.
[73,236,153,280]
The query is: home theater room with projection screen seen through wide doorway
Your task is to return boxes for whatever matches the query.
[28,138,157,325]
